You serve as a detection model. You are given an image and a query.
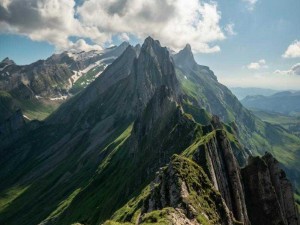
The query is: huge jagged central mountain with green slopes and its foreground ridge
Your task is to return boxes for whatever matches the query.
[0,37,299,225]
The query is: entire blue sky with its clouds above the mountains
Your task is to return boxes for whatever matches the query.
[0,0,300,90]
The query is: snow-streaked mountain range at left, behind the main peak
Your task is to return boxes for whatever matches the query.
[0,42,129,120]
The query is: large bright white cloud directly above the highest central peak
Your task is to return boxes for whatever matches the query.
[78,0,225,53]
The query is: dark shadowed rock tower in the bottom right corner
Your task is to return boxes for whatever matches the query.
[242,153,299,225]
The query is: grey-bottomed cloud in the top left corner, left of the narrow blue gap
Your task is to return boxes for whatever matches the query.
[0,0,104,50]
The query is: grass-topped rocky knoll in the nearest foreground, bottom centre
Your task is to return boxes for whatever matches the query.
[140,155,234,224]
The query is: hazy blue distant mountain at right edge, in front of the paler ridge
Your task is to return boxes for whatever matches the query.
[241,91,300,115]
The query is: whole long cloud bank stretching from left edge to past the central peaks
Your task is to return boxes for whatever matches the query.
[0,0,227,53]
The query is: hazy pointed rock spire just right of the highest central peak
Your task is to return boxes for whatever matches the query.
[174,44,197,69]
